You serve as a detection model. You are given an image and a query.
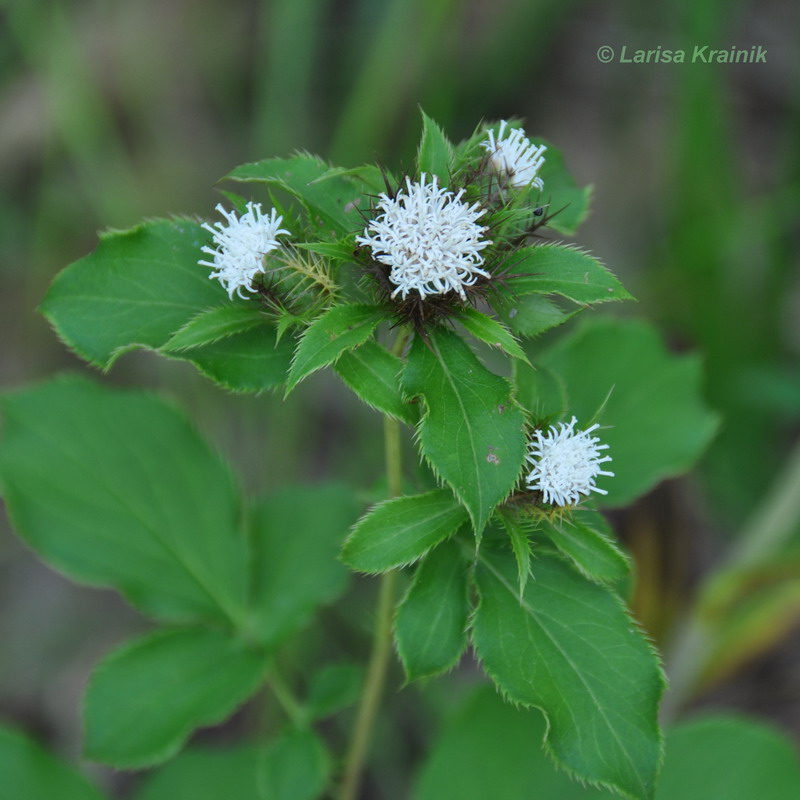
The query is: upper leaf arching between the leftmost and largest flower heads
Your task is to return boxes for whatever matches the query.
[226,154,369,234]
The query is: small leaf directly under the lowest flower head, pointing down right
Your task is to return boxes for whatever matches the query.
[539,509,631,584]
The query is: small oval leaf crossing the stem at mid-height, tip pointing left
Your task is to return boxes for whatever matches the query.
[342,489,468,573]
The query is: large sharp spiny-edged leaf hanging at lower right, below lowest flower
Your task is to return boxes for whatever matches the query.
[473,547,664,800]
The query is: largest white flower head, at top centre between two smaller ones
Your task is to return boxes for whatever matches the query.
[356,172,491,300]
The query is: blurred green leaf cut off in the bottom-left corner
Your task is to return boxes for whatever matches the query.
[0,727,103,800]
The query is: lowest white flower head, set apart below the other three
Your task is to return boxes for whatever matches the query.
[526,417,614,506]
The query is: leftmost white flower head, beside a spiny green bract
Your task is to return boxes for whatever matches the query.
[197,203,289,297]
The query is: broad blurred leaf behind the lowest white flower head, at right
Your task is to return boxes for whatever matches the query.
[541,318,718,506]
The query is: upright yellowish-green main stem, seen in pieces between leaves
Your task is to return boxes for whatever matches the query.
[339,329,408,800]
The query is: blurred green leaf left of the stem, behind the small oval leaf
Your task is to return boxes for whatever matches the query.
[247,485,358,647]
